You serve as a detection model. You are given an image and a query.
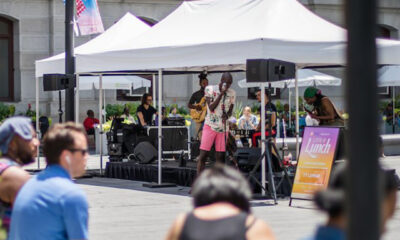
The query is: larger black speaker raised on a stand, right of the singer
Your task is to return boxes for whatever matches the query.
[246,59,296,82]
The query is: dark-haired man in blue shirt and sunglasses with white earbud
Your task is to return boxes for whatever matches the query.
[10,123,88,240]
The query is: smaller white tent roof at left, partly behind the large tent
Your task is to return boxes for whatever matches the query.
[36,12,151,77]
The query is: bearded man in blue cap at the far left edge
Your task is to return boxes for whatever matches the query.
[0,117,39,238]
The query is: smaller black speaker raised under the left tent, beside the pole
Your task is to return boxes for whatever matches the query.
[43,74,76,91]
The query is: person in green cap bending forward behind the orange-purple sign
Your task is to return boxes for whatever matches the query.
[304,87,344,126]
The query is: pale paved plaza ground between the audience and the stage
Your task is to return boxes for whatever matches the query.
[27,156,400,240]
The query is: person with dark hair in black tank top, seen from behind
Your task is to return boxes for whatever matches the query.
[166,164,275,240]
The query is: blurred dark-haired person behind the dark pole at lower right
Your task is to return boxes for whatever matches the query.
[308,166,398,240]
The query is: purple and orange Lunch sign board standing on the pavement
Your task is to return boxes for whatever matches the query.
[289,126,343,206]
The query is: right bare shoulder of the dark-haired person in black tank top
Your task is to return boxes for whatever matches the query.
[246,215,275,240]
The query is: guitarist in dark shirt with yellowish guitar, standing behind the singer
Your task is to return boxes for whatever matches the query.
[188,72,208,139]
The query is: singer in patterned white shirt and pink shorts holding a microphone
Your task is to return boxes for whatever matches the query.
[197,72,236,175]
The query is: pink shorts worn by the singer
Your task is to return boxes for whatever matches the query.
[200,124,227,152]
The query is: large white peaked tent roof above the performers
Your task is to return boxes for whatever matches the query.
[77,0,400,73]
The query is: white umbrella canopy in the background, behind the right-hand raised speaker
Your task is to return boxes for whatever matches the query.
[238,69,342,88]
